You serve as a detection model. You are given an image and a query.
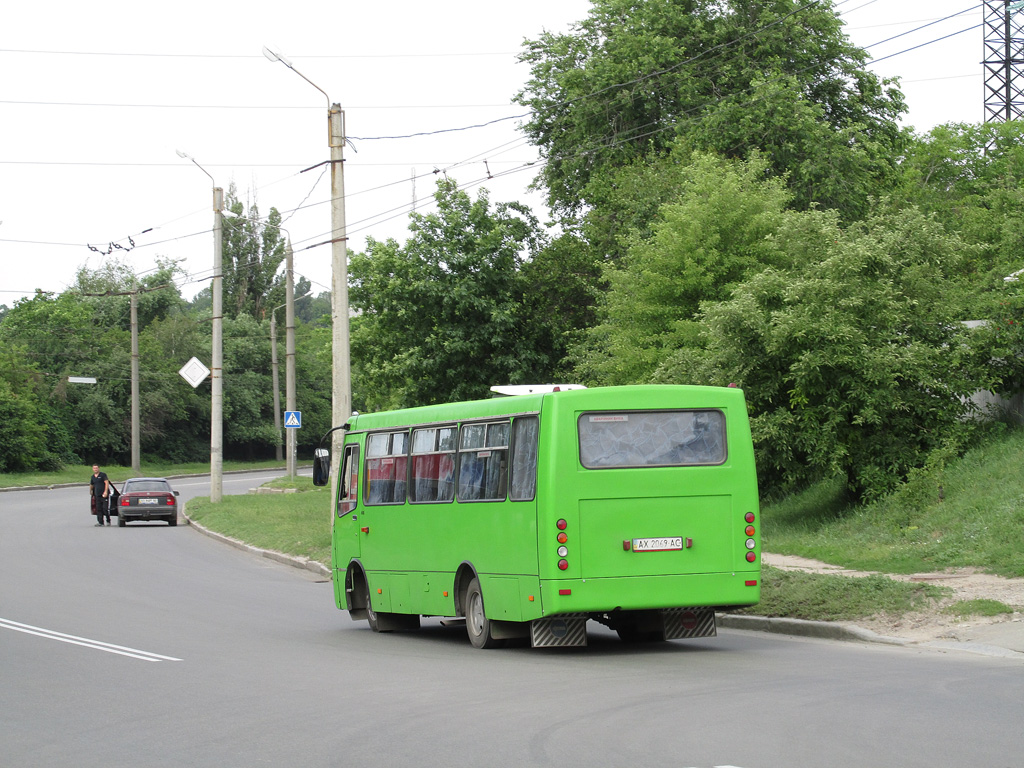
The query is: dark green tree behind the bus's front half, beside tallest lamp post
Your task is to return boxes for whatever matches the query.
[349,179,549,410]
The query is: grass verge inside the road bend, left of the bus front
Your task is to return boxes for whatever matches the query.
[185,477,331,566]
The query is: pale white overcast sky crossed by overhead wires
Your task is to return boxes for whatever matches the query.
[0,0,1003,306]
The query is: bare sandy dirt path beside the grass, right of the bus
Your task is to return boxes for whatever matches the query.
[761,553,1024,642]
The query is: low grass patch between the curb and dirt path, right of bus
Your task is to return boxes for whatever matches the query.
[738,566,949,622]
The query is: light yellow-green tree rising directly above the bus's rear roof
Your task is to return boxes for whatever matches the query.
[573,154,792,385]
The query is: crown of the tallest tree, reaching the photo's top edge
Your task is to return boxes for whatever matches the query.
[516,0,906,218]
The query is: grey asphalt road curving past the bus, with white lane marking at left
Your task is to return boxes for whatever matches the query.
[0,475,1024,768]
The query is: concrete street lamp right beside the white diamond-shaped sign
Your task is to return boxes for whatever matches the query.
[175,150,224,504]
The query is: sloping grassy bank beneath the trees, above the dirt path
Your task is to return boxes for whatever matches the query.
[761,429,1024,578]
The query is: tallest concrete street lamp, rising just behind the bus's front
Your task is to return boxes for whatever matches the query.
[263,46,352,499]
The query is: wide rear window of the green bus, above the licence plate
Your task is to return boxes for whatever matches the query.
[579,411,726,469]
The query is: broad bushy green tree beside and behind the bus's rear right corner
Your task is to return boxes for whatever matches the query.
[656,208,989,499]
